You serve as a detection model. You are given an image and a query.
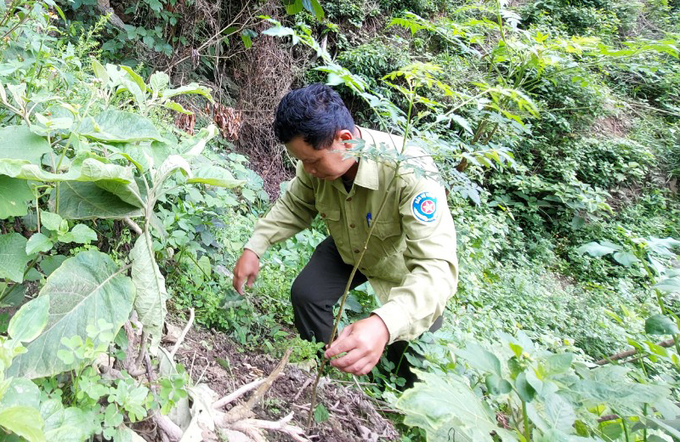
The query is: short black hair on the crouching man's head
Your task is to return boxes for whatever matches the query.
[274,84,354,150]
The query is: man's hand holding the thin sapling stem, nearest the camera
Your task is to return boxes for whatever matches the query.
[326,315,390,375]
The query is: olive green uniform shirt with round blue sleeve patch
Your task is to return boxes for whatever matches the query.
[245,128,458,343]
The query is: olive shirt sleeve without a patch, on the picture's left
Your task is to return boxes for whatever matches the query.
[244,163,317,257]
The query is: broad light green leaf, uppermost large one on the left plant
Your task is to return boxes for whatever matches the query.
[80,110,163,143]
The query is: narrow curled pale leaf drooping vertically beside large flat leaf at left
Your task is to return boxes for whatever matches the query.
[130,231,168,343]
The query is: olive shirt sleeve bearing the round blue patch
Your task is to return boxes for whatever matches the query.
[373,179,458,343]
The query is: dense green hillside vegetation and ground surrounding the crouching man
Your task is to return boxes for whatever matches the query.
[0,0,680,441]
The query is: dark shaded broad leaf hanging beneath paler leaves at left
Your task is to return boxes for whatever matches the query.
[50,182,142,219]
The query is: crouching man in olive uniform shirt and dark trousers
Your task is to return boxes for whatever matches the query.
[233,84,458,384]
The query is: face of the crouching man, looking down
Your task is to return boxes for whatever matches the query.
[286,131,356,181]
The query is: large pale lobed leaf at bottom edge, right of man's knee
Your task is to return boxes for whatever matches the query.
[396,370,517,441]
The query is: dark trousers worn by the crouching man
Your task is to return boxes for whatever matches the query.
[290,236,442,382]
